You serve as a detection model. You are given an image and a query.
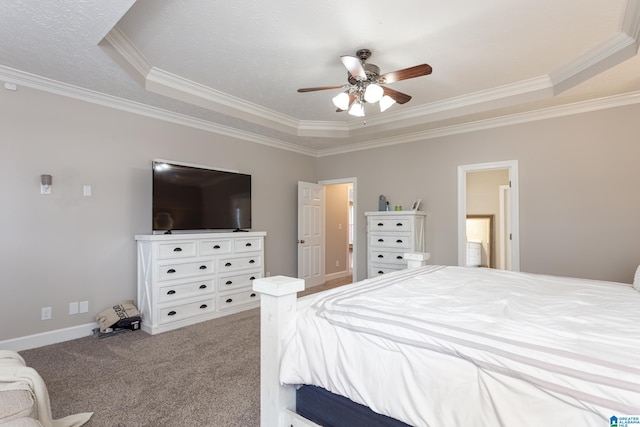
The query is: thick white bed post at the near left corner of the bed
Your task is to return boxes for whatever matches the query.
[253,276,304,427]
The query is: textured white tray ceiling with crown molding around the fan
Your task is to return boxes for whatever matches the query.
[0,0,640,153]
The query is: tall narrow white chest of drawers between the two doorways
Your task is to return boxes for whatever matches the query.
[365,211,428,277]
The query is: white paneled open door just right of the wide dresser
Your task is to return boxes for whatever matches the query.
[298,181,324,288]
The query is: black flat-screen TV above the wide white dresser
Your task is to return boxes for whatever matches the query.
[153,160,251,231]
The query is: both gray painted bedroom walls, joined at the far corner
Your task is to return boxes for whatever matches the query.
[0,83,640,341]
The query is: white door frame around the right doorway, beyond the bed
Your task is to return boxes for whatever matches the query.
[458,160,520,271]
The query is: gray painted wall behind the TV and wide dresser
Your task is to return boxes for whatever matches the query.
[0,87,316,341]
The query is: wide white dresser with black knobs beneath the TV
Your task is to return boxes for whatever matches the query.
[135,232,266,334]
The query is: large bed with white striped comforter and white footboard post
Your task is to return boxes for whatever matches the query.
[254,256,640,427]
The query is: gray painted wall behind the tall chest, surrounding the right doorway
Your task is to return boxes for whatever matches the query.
[318,106,640,283]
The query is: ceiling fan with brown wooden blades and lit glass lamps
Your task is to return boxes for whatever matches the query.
[298,49,432,117]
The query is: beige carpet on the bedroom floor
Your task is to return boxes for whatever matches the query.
[20,279,349,427]
